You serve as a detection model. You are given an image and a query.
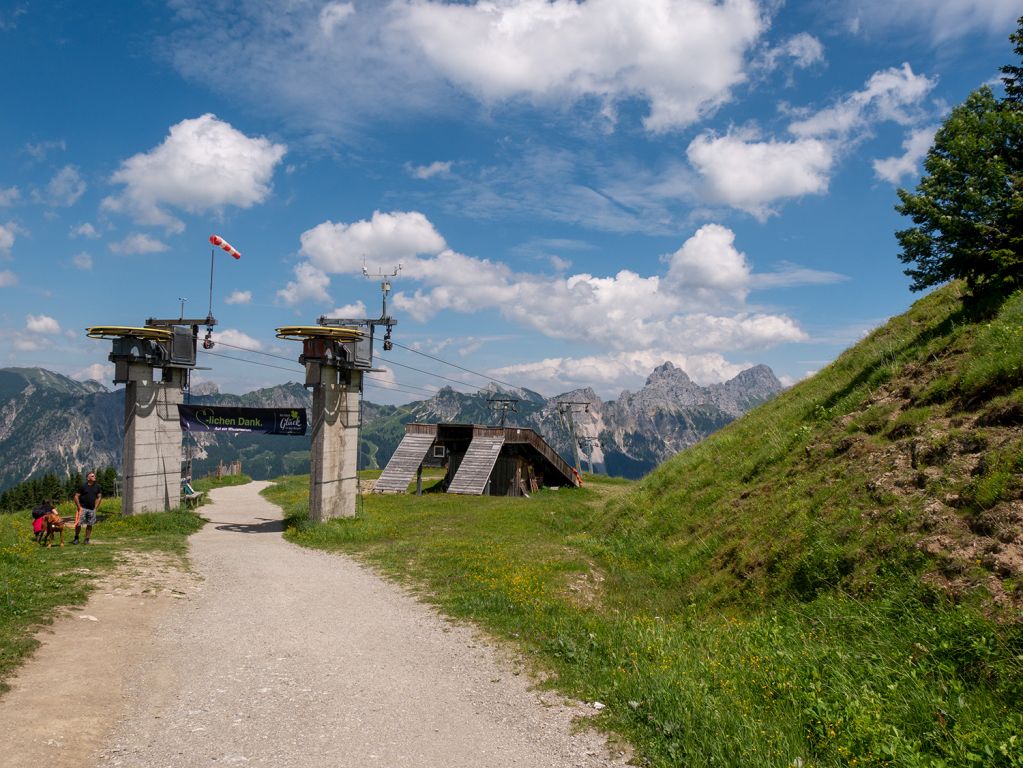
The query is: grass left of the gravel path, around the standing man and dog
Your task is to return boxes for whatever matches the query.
[0,478,249,691]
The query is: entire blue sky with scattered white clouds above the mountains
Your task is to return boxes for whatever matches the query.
[0,0,1023,403]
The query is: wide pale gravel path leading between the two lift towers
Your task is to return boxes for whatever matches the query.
[0,483,624,768]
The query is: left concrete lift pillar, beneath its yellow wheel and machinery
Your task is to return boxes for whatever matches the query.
[122,362,186,514]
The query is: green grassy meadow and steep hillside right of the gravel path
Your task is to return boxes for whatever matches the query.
[268,285,1023,768]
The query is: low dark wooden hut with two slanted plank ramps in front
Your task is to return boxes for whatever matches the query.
[373,423,580,496]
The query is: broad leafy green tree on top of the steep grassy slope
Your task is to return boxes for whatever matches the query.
[895,86,1023,296]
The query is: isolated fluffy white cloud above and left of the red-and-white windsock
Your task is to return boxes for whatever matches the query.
[102,114,286,232]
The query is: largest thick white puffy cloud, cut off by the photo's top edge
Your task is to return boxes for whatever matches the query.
[396,0,767,131]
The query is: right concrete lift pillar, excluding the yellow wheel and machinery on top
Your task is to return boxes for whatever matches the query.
[306,361,362,522]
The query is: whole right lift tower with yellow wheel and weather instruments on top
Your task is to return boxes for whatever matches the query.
[277,264,401,521]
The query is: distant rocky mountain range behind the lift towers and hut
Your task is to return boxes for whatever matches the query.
[0,363,783,489]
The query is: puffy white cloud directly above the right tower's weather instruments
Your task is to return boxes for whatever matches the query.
[302,211,445,274]
